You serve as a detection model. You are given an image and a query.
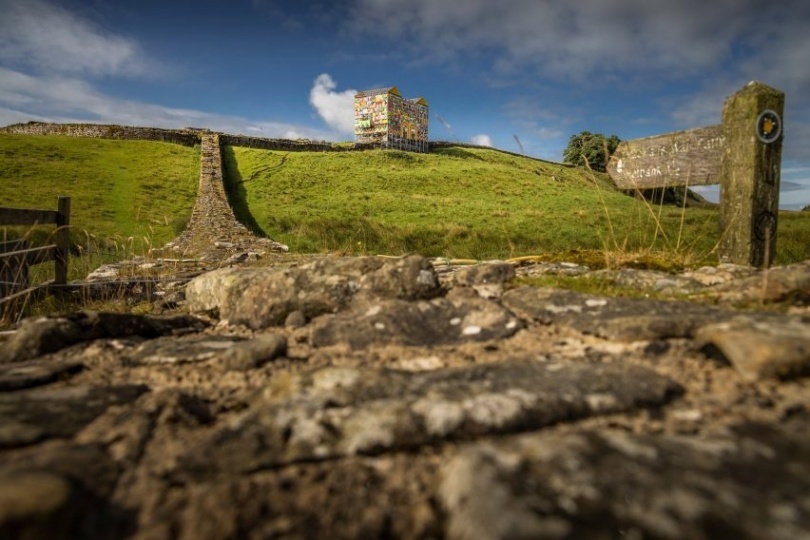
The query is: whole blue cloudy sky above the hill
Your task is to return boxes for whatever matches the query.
[0,0,810,208]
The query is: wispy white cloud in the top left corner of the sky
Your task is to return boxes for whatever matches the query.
[0,0,153,76]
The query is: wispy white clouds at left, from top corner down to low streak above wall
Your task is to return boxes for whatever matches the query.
[0,0,340,140]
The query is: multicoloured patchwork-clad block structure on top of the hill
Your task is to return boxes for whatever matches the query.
[354,86,429,152]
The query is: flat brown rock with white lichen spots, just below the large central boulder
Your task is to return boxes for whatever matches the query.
[312,297,523,349]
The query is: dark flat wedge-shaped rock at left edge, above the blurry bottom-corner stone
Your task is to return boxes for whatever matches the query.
[0,385,147,447]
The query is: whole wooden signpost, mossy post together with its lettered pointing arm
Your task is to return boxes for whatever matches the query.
[607,81,785,267]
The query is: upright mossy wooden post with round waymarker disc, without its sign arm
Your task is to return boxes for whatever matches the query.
[720,81,785,267]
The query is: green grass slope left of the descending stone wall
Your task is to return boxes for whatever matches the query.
[0,134,199,270]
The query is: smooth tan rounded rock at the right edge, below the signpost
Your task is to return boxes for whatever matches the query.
[695,316,810,380]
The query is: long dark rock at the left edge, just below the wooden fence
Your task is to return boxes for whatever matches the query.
[0,311,206,364]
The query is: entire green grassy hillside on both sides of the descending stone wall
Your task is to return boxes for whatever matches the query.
[0,134,810,276]
